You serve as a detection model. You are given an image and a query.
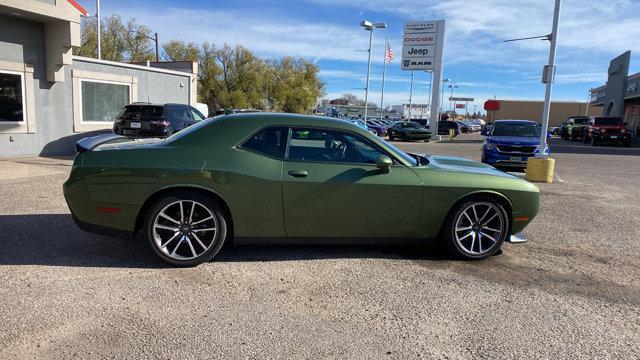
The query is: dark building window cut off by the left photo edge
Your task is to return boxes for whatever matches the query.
[0,71,25,122]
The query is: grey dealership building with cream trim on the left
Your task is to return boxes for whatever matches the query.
[0,0,197,156]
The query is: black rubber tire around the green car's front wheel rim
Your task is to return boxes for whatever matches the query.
[443,196,510,260]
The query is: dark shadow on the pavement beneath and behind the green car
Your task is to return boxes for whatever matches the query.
[0,214,450,268]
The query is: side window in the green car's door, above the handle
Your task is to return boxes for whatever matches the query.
[288,128,383,164]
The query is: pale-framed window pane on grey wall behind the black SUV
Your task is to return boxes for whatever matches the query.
[81,80,131,122]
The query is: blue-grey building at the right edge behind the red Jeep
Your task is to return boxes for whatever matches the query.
[589,51,640,143]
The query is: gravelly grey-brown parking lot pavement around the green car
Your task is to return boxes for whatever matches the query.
[0,134,640,359]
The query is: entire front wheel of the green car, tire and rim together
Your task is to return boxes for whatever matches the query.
[445,198,509,260]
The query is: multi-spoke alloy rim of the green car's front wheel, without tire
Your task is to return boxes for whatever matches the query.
[454,202,507,255]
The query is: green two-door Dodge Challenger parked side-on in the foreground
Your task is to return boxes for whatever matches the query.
[64,113,539,266]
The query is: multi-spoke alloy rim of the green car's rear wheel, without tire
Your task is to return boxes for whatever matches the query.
[153,200,218,260]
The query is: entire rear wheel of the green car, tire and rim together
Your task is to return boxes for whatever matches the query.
[145,192,227,266]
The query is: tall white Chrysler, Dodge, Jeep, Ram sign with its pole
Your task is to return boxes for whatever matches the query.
[400,20,444,135]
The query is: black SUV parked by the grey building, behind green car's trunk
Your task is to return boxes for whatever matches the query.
[113,103,205,137]
